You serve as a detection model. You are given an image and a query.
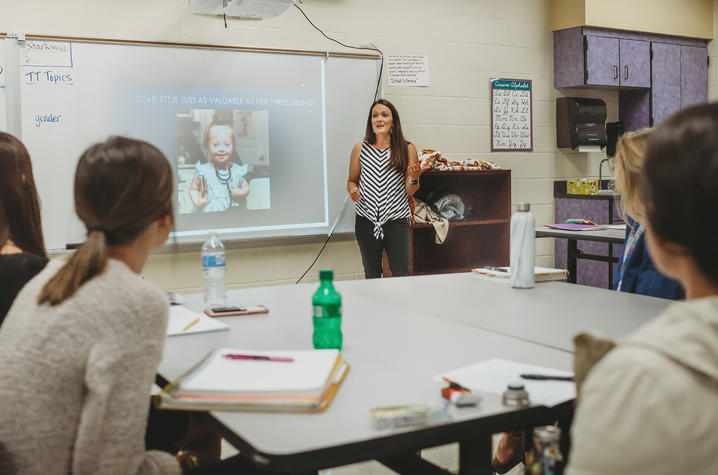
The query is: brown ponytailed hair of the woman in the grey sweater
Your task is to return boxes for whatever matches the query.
[38,137,172,305]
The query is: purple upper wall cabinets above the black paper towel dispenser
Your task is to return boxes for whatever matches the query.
[553,26,708,131]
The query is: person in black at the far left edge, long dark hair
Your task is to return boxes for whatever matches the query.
[0,132,47,324]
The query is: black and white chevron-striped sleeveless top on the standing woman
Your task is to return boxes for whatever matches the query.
[356,140,411,239]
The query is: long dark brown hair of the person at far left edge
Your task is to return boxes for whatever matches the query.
[0,132,47,257]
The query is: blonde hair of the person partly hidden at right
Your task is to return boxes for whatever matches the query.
[614,128,653,224]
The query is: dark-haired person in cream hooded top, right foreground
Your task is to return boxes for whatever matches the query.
[565,104,718,475]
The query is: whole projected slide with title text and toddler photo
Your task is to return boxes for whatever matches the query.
[115,81,328,237]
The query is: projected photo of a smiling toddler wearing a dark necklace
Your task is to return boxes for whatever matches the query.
[177,109,271,214]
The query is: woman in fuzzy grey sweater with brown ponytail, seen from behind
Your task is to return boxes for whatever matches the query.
[0,137,194,474]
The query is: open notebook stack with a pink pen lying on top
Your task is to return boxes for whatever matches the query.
[156,348,349,412]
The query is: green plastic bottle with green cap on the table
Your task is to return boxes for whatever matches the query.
[312,270,342,350]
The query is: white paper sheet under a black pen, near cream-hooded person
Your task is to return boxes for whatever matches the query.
[434,358,576,407]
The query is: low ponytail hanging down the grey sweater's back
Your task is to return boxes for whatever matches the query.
[37,228,108,306]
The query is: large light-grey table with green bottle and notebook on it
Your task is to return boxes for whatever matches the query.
[159,274,664,474]
